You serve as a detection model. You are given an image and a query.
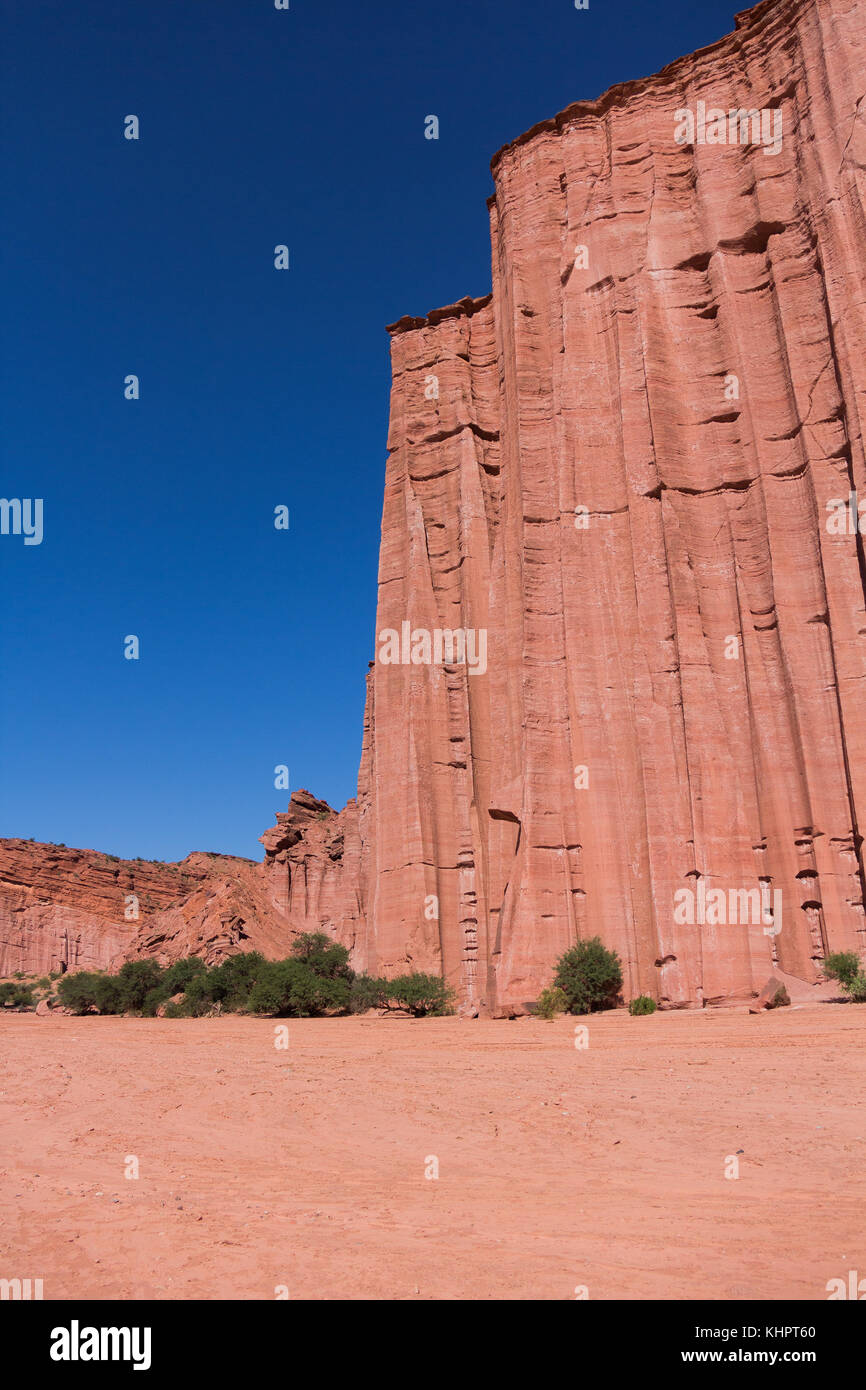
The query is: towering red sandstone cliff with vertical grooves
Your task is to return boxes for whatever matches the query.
[350,0,866,1012]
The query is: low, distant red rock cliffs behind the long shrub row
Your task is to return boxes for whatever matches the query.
[0,791,360,976]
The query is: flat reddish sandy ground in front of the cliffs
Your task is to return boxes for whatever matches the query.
[0,1004,866,1300]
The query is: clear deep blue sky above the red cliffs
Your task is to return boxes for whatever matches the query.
[0,0,740,859]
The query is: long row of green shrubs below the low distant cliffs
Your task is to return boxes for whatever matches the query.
[48,931,453,1019]
